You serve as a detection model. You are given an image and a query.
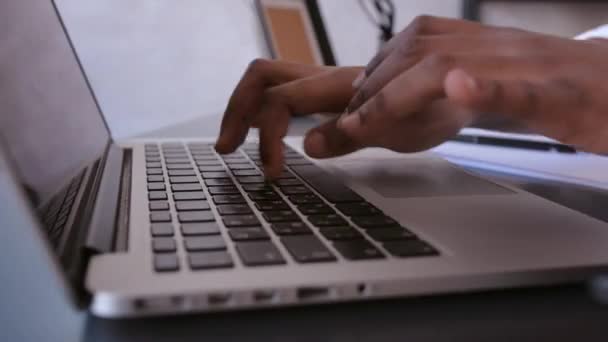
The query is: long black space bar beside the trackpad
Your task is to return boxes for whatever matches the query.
[290,165,363,203]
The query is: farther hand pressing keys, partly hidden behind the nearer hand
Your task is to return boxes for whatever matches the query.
[215,60,363,178]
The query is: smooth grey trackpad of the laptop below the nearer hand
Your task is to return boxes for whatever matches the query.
[334,157,514,198]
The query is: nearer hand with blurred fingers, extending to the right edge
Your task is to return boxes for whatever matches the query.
[338,17,608,153]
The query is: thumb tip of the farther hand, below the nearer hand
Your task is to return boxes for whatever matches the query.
[304,118,361,158]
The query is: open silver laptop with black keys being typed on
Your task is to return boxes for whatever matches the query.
[0,1,608,318]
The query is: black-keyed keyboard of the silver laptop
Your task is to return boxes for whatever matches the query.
[145,143,439,272]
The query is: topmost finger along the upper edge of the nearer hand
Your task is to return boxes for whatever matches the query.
[355,15,485,86]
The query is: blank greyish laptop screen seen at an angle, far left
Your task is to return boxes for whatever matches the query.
[0,0,110,206]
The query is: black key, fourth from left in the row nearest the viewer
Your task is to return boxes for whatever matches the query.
[281,235,336,263]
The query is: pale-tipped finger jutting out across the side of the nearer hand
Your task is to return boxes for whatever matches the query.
[444,69,589,138]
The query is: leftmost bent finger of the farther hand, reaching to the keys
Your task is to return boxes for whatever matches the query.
[215,59,329,153]
